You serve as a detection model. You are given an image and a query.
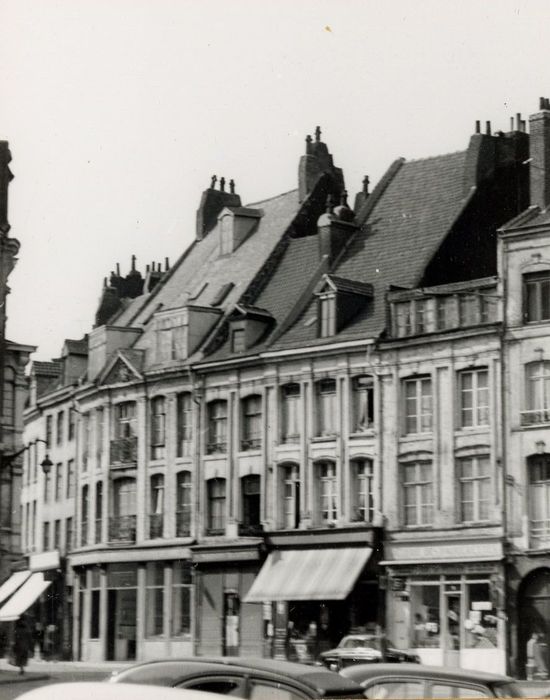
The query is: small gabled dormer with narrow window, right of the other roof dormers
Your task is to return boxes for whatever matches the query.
[315,274,373,338]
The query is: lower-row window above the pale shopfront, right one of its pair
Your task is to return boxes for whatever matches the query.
[457,456,491,522]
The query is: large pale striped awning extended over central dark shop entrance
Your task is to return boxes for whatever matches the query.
[244,547,372,603]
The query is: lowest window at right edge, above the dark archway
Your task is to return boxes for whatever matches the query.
[527,454,550,549]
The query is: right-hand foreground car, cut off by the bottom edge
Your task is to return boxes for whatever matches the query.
[340,664,522,700]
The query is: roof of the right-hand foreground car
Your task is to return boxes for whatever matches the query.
[340,663,515,683]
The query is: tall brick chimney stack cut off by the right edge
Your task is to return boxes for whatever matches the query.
[529,97,550,209]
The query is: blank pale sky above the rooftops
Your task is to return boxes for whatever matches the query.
[0,0,550,359]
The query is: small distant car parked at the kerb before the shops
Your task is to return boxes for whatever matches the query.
[319,634,420,671]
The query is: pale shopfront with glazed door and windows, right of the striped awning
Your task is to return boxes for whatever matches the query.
[382,539,507,673]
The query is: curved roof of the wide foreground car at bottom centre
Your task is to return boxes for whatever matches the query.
[112,656,362,695]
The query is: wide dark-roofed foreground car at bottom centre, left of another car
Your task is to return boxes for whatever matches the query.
[109,657,364,700]
